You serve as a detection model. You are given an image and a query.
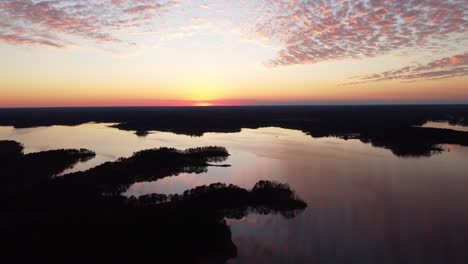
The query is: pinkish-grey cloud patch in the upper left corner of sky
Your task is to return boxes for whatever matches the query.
[0,0,177,47]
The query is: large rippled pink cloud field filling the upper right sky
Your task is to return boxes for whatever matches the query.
[257,0,468,66]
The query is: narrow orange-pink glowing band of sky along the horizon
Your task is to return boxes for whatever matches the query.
[0,88,466,108]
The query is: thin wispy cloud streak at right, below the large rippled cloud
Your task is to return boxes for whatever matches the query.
[343,53,468,85]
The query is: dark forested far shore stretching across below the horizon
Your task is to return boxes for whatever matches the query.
[0,105,468,156]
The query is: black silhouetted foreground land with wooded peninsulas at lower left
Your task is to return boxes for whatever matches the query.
[0,141,307,263]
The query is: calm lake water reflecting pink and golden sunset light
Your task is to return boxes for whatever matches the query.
[0,124,468,263]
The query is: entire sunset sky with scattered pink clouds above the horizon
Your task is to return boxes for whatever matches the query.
[0,0,468,107]
